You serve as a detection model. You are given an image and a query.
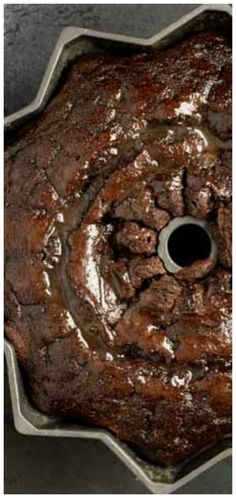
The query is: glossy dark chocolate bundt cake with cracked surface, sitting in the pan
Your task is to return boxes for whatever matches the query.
[5,32,231,465]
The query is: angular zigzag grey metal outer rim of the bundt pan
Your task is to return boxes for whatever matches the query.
[5,4,232,494]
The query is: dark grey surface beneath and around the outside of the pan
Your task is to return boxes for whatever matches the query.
[5,4,232,494]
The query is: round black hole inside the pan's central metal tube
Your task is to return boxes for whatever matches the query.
[168,223,211,267]
